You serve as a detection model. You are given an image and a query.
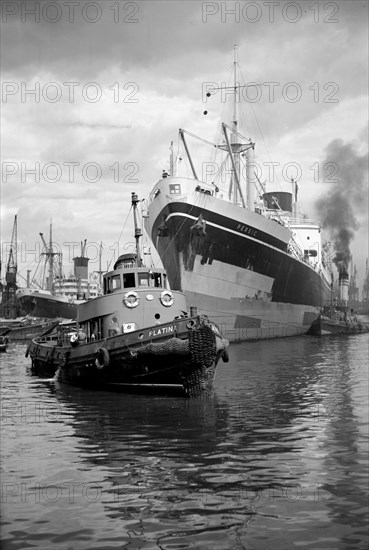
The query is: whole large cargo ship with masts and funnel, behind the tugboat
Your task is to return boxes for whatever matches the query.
[145,50,332,341]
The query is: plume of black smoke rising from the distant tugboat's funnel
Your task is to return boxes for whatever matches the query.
[315,139,368,273]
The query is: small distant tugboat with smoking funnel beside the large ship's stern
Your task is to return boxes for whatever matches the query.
[309,269,369,336]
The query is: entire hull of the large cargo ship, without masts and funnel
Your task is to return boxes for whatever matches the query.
[147,178,330,341]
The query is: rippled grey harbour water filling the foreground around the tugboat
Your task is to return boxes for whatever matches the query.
[1,334,369,550]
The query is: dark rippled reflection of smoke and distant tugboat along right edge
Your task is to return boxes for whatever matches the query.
[319,339,368,544]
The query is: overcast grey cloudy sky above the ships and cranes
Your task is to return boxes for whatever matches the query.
[1,0,368,294]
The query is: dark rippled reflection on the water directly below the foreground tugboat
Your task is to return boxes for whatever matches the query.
[46,386,248,548]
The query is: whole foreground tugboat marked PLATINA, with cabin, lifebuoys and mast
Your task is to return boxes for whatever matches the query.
[26,193,229,397]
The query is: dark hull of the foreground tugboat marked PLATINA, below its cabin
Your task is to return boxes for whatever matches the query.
[26,317,228,397]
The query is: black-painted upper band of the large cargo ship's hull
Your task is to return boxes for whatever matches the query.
[152,203,330,307]
